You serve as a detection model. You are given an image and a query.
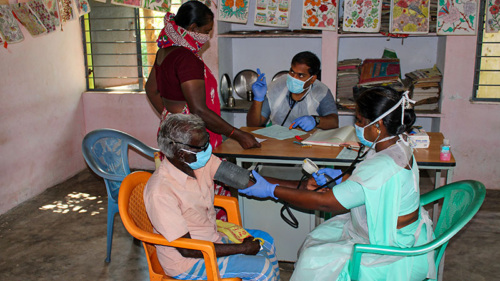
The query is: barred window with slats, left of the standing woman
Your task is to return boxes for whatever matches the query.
[82,0,181,91]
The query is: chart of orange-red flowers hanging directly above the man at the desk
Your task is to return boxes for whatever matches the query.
[302,0,338,30]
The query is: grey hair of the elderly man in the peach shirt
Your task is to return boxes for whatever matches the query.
[158,113,206,158]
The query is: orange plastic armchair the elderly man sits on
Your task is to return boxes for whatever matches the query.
[118,172,241,281]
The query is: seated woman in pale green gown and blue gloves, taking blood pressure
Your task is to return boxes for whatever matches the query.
[239,87,435,280]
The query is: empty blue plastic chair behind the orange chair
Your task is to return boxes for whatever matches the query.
[82,129,158,262]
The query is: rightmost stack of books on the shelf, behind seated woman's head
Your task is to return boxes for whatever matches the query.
[405,66,442,111]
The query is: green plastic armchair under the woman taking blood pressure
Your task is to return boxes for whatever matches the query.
[349,180,486,280]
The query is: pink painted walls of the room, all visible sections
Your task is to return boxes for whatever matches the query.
[0,9,500,214]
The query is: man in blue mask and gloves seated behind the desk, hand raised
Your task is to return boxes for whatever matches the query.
[247,51,339,131]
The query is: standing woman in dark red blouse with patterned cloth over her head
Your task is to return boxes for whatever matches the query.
[146,1,260,148]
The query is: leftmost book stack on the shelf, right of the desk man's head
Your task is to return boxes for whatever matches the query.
[337,59,362,105]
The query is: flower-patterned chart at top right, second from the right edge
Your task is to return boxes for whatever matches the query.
[436,0,479,35]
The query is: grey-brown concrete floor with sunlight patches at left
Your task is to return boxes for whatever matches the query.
[0,167,500,281]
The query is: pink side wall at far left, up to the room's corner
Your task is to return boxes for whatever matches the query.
[0,20,85,214]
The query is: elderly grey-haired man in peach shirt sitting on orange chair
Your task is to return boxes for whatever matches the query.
[144,114,279,280]
